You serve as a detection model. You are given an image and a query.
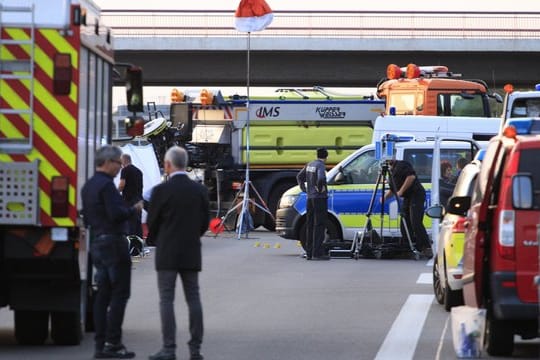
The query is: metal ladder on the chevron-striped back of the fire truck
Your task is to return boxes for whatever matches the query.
[0,3,36,153]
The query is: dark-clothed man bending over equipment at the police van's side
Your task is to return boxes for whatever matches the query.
[384,159,433,258]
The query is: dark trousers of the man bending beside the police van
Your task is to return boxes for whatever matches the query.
[400,189,431,251]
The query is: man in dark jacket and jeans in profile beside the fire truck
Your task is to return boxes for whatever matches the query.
[81,145,143,359]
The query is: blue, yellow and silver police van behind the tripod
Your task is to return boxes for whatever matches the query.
[276,136,482,252]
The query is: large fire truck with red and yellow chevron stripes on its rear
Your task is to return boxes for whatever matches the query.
[0,0,142,345]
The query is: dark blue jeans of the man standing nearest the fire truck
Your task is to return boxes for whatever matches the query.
[90,235,131,350]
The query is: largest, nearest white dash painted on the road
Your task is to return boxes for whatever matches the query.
[375,294,434,360]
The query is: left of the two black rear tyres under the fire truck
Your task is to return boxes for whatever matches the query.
[15,310,49,345]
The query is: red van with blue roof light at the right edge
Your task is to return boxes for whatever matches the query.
[447,118,540,356]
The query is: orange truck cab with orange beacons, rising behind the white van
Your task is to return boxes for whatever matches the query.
[377,64,502,117]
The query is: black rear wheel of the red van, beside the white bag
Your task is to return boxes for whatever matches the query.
[485,311,514,356]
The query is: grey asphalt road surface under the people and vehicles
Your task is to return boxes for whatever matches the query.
[0,231,540,360]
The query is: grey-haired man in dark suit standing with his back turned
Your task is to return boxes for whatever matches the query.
[147,146,210,360]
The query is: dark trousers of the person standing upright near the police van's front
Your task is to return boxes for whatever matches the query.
[306,198,328,258]
